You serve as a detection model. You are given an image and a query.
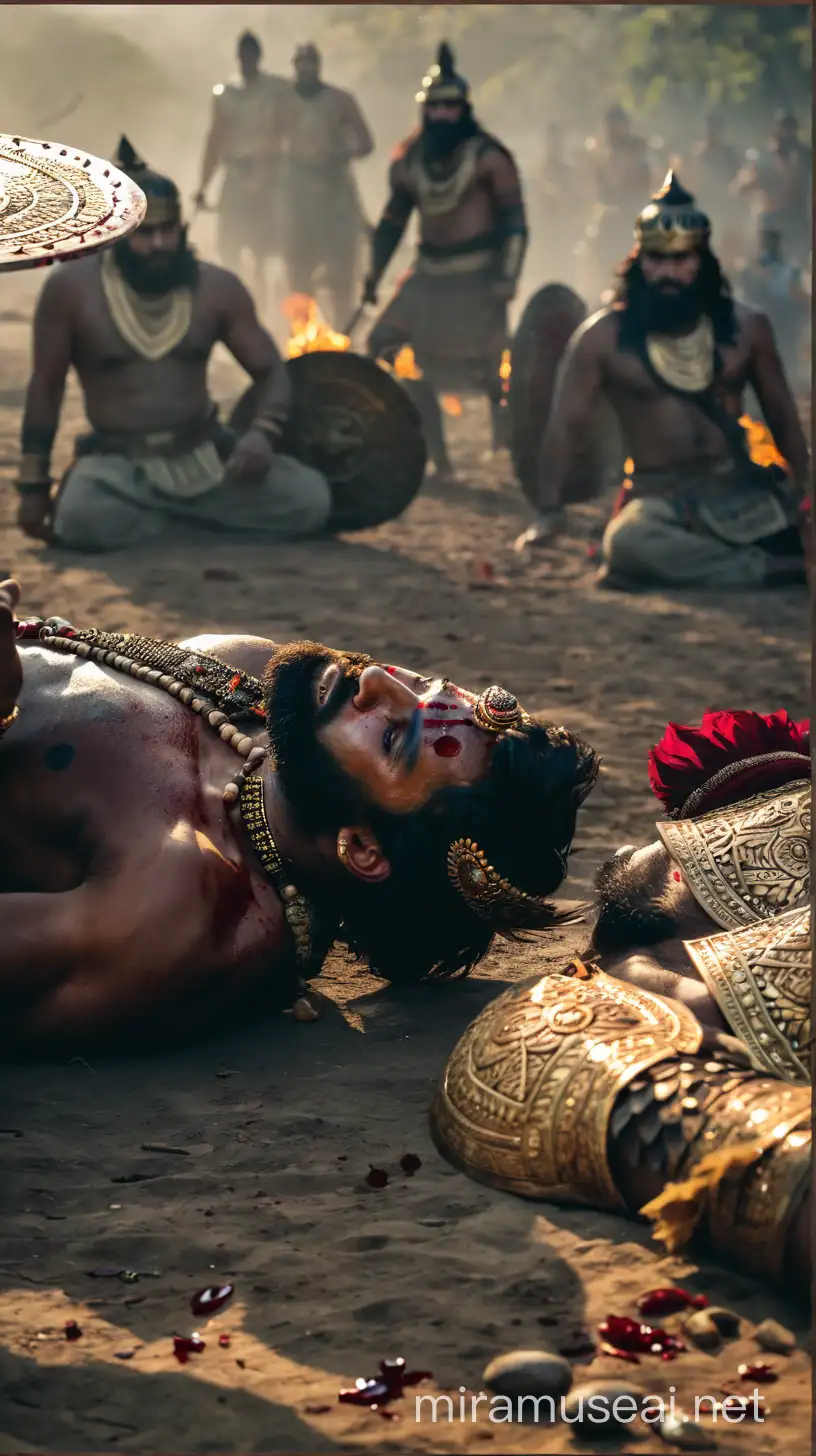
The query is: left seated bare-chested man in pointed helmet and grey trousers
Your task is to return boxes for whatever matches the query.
[17,138,331,550]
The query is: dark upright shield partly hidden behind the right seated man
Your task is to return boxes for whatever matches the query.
[509,282,593,504]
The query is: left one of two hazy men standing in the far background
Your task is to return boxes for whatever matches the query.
[195,31,291,310]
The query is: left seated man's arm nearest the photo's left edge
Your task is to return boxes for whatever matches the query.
[17,265,76,537]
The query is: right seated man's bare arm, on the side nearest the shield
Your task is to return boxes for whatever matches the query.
[536,314,612,515]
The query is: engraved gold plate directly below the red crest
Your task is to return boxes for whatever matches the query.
[657,779,810,930]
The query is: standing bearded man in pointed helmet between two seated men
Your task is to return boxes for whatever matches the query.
[364,45,527,479]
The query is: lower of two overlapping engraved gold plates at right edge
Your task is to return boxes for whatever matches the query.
[685,906,813,1083]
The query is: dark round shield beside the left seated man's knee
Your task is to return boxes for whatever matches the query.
[230,349,427,531]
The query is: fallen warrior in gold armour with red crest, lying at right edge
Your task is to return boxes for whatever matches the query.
[431,712,812,1289]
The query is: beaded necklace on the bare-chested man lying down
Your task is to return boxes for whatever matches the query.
[31,617,313,965]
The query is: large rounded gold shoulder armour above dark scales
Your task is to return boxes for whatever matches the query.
[431,961,702,1208]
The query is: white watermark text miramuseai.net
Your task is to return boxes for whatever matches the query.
[414,1385,765,1425]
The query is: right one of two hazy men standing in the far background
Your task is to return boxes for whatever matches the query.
[281,45,374,329]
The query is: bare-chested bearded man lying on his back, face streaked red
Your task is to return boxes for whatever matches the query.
[0,582,597,1051]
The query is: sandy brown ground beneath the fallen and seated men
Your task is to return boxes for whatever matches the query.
[0,326,810,1456]
